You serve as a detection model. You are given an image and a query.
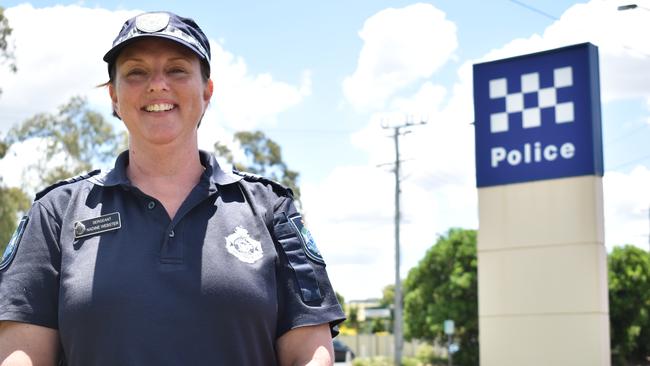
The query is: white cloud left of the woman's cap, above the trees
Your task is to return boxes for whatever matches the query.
[0,4,137,132]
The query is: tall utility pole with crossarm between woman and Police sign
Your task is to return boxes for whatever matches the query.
[382,120,426,366]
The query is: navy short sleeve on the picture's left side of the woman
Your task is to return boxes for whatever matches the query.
[0,202,61,329]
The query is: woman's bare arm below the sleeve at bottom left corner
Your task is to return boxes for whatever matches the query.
[0,321,59,366]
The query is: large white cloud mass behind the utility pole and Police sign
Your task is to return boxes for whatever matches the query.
[312,0,650,298]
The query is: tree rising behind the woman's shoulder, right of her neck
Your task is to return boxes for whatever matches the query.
[214,131,300,201]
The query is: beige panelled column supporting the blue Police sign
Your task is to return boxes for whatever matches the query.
[478,176,610,366]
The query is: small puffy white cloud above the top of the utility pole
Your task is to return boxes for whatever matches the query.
[343,4,457,109]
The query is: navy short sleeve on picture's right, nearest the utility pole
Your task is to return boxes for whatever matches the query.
[273,197,345,337]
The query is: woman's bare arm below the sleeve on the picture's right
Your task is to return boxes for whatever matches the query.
[274,323,334,366]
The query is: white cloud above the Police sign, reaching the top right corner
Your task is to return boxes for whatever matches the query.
[473,0,650,102]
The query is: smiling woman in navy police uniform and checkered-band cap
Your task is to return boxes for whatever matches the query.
[0,12,344,366]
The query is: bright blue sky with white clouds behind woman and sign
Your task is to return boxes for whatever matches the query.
[0,0,650,300]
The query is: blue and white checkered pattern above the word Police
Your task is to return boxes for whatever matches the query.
[490,66,574,133]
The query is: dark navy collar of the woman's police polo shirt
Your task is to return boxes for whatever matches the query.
[89,150,242,188]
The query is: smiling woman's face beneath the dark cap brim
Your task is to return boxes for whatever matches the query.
[109,38,212,147]
